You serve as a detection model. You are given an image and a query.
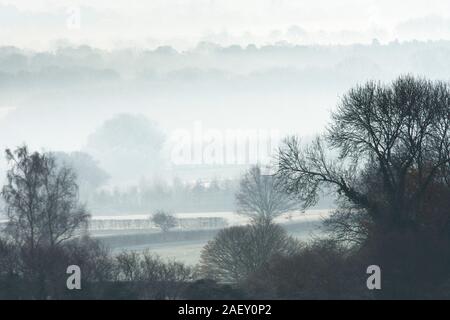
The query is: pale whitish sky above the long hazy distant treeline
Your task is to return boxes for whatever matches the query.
[0,0,450,49]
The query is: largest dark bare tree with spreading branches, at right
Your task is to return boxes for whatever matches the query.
[277,76,450,238]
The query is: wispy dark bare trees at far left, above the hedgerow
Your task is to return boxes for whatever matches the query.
[2,147,89,250]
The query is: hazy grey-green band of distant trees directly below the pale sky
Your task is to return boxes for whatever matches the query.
[0,39,450,89]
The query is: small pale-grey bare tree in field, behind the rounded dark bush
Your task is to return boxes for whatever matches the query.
[236,166,298,223]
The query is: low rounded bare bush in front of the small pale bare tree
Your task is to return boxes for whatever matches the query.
[200,223,300,283]
